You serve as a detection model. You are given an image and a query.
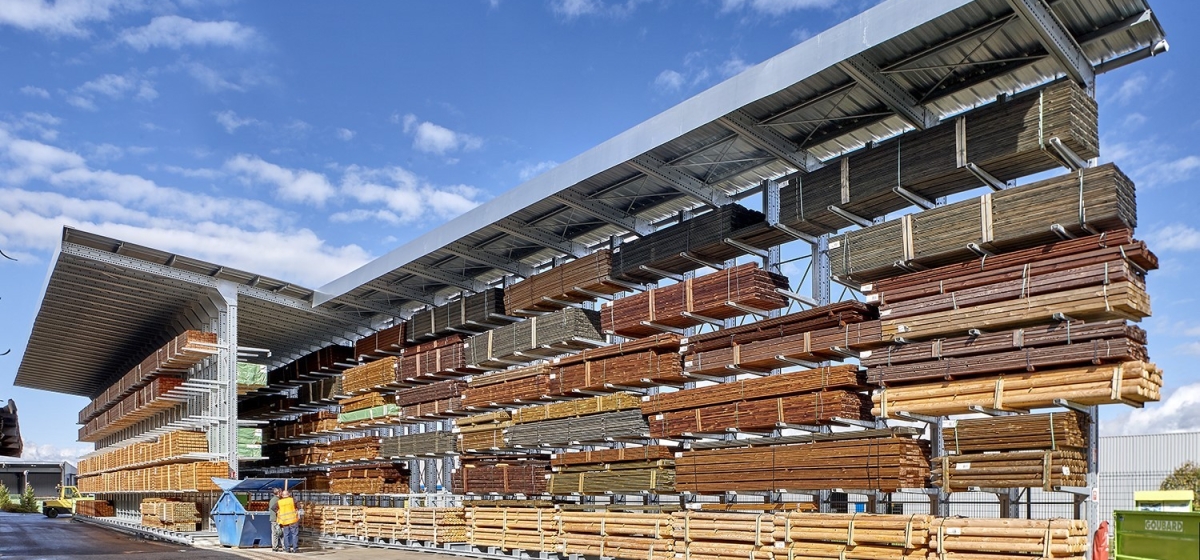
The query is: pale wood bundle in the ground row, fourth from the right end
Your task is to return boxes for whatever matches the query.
[558,511,674,560]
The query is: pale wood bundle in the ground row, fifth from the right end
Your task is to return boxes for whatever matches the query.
[466,506,558,553]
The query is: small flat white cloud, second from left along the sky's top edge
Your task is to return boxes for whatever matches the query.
[121,16,257,52]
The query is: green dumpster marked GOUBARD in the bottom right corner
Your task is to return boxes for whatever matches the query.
[1112,511,1200,560]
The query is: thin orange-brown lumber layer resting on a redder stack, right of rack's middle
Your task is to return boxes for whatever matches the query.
[642,366,866,415]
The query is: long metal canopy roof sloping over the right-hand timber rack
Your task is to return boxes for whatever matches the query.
[314,0,1166,317]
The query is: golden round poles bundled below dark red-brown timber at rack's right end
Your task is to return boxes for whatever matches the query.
[871,362,1163,419]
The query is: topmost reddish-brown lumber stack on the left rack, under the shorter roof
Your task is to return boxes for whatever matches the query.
[79,331,217,423]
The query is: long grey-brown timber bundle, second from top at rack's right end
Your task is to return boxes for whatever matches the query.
[829,163,1138,282]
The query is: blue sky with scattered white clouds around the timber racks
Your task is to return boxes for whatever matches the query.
[0,0,1200,457]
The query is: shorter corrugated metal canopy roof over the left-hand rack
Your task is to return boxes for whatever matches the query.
[16,228,370,397]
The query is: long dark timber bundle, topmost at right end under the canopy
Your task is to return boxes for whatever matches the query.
[758,82,1099,243]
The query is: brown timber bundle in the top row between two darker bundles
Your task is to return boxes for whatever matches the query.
[504,249,626,315]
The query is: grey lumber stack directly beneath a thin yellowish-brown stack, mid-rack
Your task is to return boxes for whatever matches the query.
[505,410,649,447]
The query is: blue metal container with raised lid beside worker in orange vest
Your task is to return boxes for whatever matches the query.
[211,478,304,548]
